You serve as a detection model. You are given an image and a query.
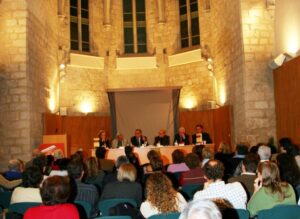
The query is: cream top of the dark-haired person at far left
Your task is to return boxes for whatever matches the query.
[10,187,42,204]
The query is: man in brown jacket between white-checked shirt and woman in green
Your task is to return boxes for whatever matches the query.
[228,153,259,194]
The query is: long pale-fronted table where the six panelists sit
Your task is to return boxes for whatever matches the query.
[92,144,214,165]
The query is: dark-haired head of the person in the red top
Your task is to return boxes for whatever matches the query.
[40,176,71,205]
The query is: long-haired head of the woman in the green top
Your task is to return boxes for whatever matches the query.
[257,161,284,200]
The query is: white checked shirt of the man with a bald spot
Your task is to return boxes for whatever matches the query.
[194,181,247,209]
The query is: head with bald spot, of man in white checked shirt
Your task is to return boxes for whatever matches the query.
[203,160,224,182]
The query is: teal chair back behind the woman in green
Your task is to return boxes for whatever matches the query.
[258,205,300,219]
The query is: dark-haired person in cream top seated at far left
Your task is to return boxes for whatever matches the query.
[10,166,43,204]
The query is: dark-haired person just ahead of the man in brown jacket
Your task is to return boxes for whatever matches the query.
[230,144,248,176]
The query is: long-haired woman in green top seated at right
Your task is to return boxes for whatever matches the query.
[247,161,296,217]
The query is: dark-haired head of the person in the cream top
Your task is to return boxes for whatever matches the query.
[22,165,43,188]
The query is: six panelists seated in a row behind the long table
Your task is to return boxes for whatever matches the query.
[98,124,212,148]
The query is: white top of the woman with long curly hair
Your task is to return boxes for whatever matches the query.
[140,192,187,218]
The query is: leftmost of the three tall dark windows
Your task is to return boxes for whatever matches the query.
[70,0,90,52]
